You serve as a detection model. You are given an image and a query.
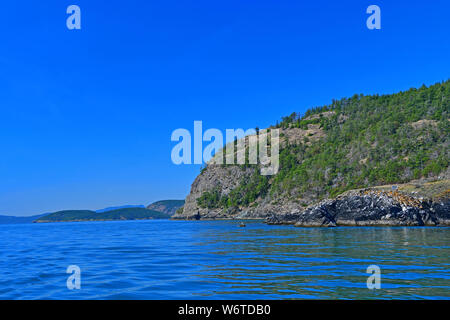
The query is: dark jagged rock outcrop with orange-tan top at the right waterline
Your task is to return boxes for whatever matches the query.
[266,189,450,227]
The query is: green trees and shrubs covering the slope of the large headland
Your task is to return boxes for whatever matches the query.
[197,80,450,208]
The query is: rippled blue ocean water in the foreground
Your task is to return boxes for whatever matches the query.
[0,220,450,299]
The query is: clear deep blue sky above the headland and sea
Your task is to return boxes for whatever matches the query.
[0,0,450,215]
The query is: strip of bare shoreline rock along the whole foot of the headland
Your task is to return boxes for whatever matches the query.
[172,180,450,227]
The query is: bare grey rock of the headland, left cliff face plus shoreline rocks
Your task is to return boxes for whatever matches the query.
[172,154,450,227]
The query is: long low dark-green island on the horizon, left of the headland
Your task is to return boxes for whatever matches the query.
[34,207,170,222]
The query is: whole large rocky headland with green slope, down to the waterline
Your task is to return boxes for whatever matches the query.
[173,81,450,226]
